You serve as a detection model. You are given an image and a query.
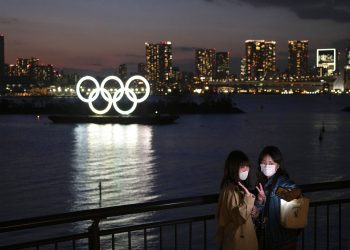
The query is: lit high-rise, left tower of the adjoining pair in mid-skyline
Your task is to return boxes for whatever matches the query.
[196,49,215,83]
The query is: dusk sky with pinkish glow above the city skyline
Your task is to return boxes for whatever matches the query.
[0,0,350,73]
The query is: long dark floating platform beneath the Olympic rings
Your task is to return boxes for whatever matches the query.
[48,115,179,125]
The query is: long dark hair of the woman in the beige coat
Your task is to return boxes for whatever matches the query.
[220,150,250,189]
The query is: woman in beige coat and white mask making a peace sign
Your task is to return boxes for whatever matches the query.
[216,151,258,250]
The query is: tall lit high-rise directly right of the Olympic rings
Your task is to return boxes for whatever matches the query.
[146,41,173,93]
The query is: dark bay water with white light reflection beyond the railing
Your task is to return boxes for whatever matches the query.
[0,95,350,248]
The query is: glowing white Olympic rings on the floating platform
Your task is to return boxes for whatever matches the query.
[76,76,151,115]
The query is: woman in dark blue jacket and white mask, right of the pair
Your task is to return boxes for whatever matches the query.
[255,146,300,250]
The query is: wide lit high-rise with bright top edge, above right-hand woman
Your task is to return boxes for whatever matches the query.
[245,40,276,80]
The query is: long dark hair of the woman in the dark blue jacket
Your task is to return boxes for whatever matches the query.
[257,145,289,186]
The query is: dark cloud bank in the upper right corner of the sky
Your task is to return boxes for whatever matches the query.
[203,0,350,23]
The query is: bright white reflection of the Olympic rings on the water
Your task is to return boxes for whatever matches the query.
[72,124,156,210]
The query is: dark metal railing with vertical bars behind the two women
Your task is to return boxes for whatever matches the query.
[0,180,350,250]
